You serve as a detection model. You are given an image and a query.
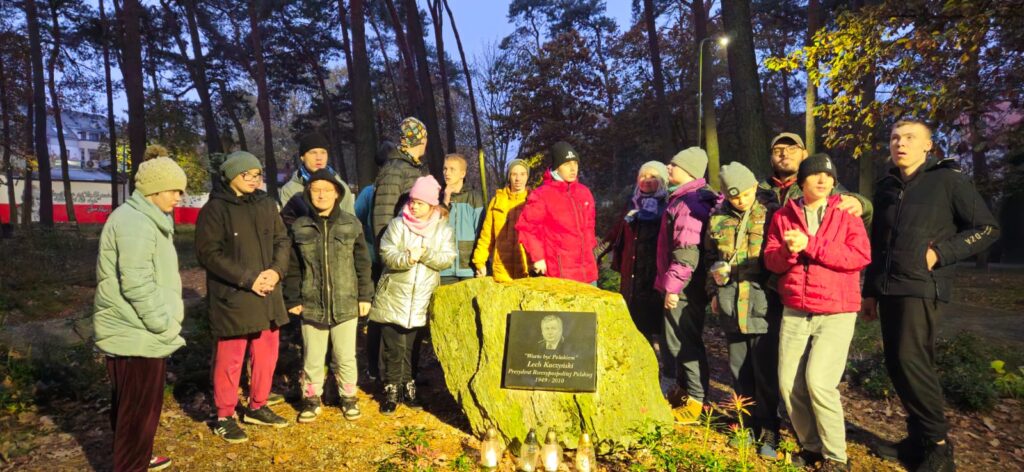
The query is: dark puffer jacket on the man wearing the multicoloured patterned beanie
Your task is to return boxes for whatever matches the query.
[373,149,427,241]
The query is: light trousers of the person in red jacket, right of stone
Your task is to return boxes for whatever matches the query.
[778,307,857,463]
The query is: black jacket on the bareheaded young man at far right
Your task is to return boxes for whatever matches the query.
[864,158,999,301]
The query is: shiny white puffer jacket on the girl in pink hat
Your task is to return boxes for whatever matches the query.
[370,215,456,329]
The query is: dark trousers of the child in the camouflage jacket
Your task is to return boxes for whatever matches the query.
[725,313,782,434]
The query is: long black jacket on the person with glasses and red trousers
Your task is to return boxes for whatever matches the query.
[196,190,291,338]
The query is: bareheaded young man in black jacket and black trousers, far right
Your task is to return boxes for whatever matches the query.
[861,121,999,471]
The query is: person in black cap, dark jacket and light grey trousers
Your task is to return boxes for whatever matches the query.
[285,169,374,423]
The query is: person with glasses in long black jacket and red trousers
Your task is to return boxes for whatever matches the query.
[196,151,291,442]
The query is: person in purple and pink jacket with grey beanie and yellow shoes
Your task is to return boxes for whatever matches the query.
[654,147,722,424]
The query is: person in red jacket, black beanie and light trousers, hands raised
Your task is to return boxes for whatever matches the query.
[764,154,871,470]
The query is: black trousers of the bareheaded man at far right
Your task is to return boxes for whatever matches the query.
[879,297,949,442]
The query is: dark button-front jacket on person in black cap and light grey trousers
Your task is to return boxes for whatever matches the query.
[285,202,374,326]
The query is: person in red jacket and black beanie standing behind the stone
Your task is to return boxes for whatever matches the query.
[515,141,597,284]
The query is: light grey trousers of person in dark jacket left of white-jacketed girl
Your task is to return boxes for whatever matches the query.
[300,317,358,397]
